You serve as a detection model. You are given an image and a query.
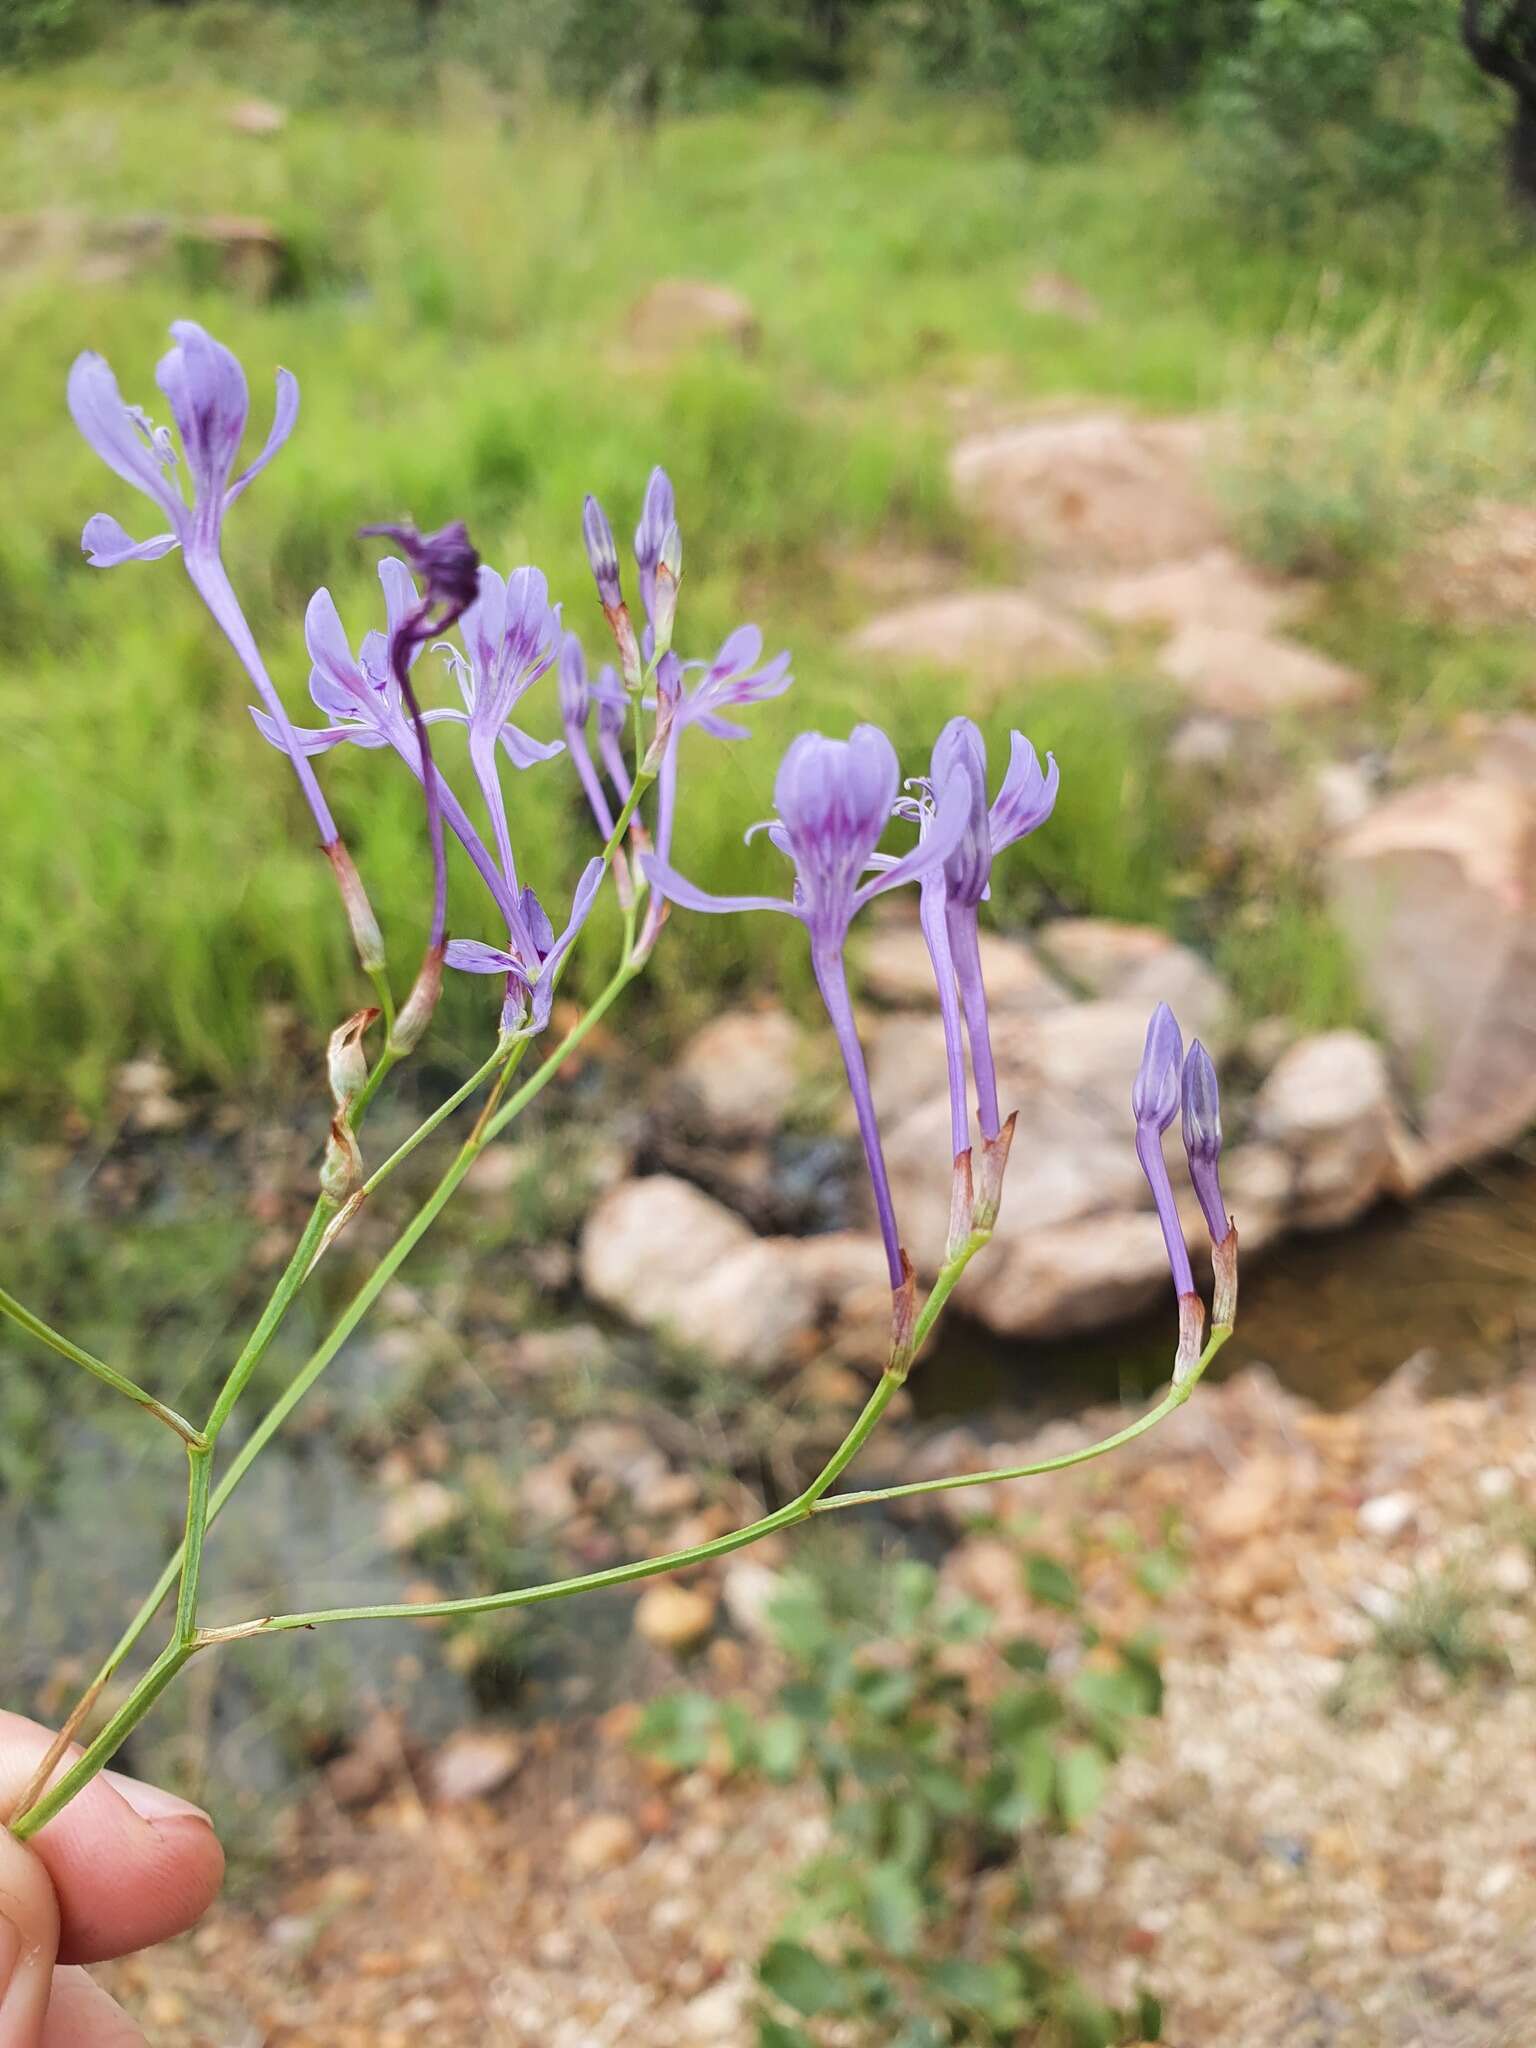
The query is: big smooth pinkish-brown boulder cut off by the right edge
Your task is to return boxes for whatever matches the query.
[1329,776,1536,1186]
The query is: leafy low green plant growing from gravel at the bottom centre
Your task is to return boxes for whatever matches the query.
[639,1552,1161,2048]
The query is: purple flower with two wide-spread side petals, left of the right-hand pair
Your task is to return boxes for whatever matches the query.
[641,725,965,1294]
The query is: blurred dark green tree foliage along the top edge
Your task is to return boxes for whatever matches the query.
[0,0,1536,229]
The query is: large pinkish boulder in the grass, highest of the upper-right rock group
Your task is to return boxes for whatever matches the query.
[950,412,1221,569]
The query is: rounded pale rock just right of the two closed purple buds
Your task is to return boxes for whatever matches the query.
[1253,1030,1405,1229]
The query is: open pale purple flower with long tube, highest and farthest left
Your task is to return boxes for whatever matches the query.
[68,319,339,851]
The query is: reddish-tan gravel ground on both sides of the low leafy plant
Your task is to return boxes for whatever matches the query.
[99,1368,1536,2048]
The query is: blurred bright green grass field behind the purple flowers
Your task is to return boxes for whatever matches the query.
[0,20,1536,1106]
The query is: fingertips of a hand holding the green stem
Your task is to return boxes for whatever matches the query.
[0,1714,223,2048]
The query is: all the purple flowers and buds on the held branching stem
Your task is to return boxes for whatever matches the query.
[70,322,1235,1370]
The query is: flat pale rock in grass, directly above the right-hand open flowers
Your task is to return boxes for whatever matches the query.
[848,590,1104,709]
